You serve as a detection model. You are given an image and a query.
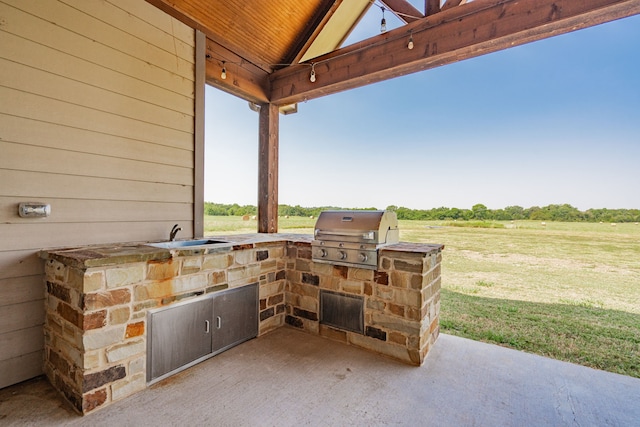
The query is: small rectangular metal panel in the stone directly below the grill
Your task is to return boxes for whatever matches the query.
[320,290,364,334]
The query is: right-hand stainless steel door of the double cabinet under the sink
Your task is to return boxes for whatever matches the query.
[213,283,258,353]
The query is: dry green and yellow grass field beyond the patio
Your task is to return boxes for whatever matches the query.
[205,217,640,378]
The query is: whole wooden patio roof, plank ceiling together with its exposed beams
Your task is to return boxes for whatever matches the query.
[147,0,640,105]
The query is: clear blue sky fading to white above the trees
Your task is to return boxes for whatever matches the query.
[205,7,640,210]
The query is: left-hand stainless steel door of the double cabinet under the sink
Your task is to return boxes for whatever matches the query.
[147,298,212,381]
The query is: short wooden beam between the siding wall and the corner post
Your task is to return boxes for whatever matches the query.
[207,38,269,104]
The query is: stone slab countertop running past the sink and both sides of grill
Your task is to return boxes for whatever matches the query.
[40,233,444,269]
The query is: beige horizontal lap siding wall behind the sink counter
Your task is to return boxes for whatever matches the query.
[0,0,194,388]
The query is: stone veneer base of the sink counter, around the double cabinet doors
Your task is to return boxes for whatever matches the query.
[44,243,285,414]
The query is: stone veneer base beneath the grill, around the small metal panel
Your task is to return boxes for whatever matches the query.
[285,243,442,365]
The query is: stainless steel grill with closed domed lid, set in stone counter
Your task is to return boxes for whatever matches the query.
[311,211,399,269]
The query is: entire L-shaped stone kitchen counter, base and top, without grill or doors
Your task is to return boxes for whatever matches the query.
[41,234,443,414]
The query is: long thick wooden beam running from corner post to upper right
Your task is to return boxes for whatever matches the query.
[270,0,640,104]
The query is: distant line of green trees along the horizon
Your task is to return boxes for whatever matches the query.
[204,202,640,226]
